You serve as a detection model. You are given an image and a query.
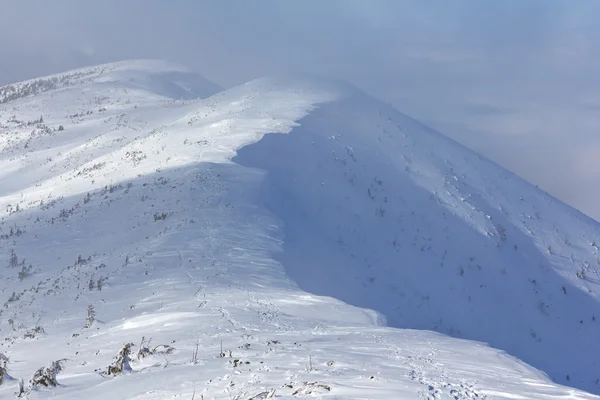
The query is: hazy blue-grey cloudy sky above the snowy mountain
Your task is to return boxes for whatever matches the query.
[0,0,600,220]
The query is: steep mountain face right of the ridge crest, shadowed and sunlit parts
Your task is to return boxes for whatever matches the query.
[234,76,600,390]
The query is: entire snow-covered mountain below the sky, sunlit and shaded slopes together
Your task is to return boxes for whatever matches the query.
[0,61,600,400]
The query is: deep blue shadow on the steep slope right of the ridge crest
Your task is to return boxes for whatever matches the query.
[234,99,600,392]
